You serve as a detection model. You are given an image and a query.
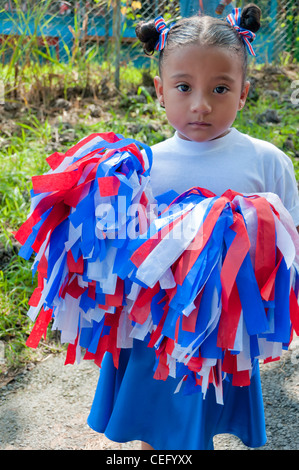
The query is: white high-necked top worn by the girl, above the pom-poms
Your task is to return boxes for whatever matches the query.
[151,128,299,226]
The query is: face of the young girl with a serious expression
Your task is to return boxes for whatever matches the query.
[154,44,249,142]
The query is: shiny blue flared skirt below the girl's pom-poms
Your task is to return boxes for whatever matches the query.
[87,340,266,450]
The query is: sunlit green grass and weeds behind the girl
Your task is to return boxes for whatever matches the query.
[0,60,299,372]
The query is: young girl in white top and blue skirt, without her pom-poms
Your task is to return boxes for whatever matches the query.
[88,5,299,450]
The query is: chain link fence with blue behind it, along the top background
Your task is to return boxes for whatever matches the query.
[0,0,299,67]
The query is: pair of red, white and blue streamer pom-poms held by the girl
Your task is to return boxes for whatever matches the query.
[16,133,299,403]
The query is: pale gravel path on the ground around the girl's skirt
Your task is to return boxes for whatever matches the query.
[0,338,299,450]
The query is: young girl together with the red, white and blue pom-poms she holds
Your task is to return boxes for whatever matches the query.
[15,2,299,450]
